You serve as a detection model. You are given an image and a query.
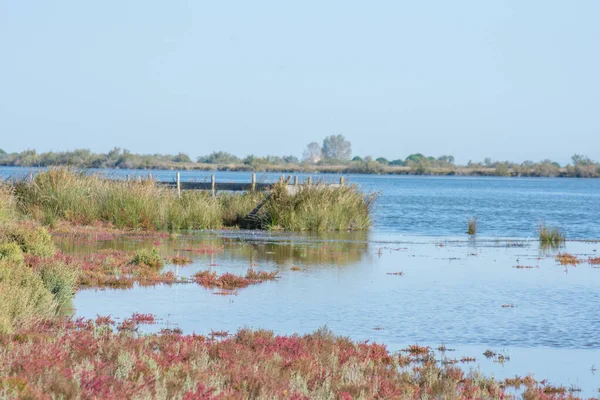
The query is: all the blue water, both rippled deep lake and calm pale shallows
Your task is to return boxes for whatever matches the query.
[0,169,600,397]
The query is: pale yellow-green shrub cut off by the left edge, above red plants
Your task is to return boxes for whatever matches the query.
[0,260,57,333]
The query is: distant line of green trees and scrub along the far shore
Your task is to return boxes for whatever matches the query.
[0,135,600,177]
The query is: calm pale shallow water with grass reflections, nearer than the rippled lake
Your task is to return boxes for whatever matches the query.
[69,232,600,396]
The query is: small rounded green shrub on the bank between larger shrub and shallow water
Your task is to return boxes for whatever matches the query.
[39,261,79,307]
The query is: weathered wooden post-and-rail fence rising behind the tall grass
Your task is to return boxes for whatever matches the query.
[127,172,346,196]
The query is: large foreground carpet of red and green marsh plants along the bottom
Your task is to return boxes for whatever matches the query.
[0,314,516,400]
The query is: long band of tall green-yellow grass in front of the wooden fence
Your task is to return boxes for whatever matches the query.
[15,169,373,231]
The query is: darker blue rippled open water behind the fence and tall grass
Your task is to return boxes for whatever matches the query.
[0,167,600,239]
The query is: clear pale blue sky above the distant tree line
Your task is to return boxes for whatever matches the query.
[0,0,600,163]
